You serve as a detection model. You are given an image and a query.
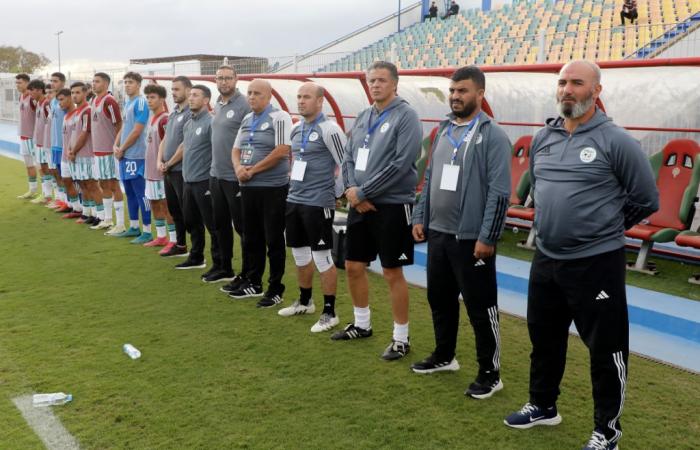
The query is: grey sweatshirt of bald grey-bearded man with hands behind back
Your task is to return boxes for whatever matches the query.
[530,110,659,259]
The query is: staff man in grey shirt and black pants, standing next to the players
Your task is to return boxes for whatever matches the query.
[158,76,192,257]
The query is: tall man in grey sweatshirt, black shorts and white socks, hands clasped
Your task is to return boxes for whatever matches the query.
[332,61,422,360]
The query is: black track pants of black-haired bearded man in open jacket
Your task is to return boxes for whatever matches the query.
[427,230,500,373]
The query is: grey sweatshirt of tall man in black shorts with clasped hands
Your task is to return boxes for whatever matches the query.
[343,97,423,204]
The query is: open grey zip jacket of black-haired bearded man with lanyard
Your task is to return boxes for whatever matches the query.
[413,113,511,245]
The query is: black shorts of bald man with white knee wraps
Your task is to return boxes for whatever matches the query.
[285,202,335,251]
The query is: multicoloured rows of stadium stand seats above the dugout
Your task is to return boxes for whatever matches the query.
[325,0,700,72]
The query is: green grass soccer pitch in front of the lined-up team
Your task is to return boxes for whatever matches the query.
[0,159,700,450]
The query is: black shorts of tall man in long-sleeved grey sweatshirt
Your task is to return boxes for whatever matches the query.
[346,204,414,269]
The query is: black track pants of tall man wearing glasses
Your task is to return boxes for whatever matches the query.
[209,177,248,273]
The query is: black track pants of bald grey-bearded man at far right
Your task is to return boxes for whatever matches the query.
[527,248,629,442]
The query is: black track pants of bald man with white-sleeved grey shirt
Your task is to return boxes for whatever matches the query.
[241,186,287,295]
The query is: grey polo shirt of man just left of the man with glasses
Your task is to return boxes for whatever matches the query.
[182,108,212,183]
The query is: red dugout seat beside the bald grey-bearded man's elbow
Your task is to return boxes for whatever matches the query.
[625,139,700,274]
